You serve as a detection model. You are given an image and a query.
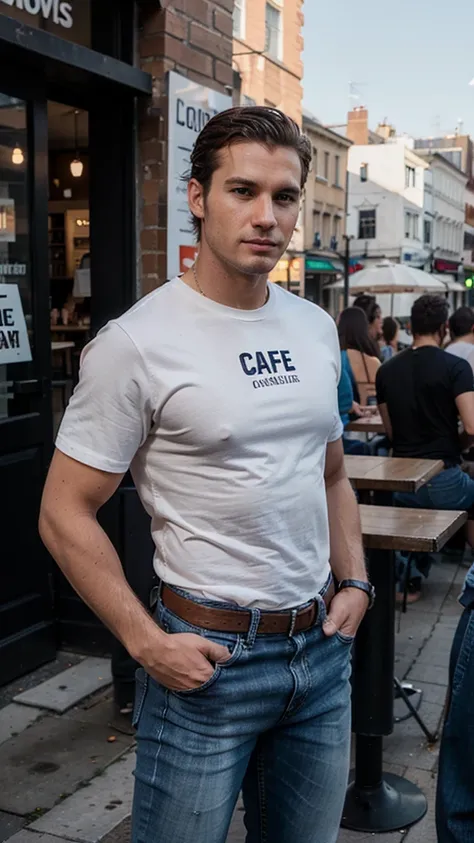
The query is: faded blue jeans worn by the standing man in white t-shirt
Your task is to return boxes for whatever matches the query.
[132,596,352,843]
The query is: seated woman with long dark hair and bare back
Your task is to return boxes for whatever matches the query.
[338,307,380,407]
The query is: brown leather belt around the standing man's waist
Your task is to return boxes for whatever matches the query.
[161,583,335,635]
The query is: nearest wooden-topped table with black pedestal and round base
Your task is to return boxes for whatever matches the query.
[342,505,467,832]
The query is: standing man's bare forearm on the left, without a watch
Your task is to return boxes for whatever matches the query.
[40,513,164,661]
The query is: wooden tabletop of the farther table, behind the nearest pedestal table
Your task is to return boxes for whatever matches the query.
[344,454,444,492]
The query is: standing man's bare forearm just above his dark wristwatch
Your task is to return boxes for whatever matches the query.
[326,476,367,582]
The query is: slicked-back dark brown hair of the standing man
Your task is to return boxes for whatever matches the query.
[186,106,312,241]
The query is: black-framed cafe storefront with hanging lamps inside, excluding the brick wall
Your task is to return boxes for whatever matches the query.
[0,0,151,684]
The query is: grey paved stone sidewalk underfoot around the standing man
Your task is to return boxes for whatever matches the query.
[0,558,466,843]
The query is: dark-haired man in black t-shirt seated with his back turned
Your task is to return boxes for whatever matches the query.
[376,295,474,602]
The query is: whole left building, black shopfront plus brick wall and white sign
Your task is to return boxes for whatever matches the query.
[0,0,233,682]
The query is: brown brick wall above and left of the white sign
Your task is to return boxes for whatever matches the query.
[137,0,234,294]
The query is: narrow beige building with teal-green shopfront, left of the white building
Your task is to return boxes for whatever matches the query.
[303,113,351,305]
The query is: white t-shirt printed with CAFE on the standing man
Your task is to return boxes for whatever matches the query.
[56,278,342,609]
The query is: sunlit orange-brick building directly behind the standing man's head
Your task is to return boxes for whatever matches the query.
[233,0,304,295]
